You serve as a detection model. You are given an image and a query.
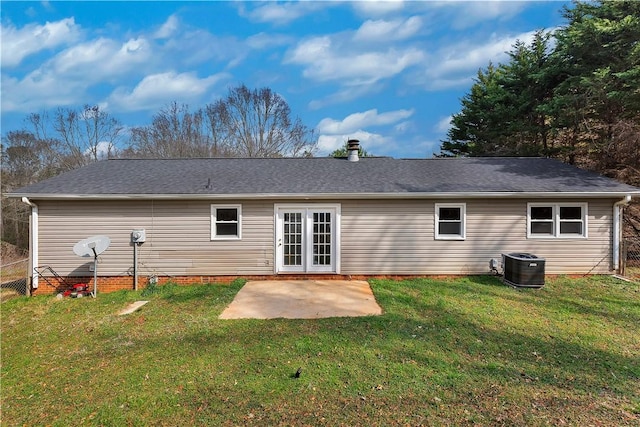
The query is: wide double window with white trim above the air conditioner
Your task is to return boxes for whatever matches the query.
[527,203,587,238]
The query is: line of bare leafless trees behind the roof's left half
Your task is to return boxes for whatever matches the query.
[1,85,316,248]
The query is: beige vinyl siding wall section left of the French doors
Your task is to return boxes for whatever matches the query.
[39,201,274,276]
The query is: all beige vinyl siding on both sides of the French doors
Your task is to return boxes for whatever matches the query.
[38,198,615,286]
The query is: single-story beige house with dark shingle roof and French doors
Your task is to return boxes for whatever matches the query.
[11,152,640,289]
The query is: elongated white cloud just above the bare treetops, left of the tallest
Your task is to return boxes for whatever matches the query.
[109,72,227,111]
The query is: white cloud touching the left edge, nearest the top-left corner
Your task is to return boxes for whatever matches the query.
[0,18,80,68]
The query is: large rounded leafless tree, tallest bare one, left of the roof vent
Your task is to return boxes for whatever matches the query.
[206,85,316,157]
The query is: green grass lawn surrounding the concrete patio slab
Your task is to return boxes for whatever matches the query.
[1,277,640,426]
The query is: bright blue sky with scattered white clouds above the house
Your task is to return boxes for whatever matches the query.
[1,1,567,158]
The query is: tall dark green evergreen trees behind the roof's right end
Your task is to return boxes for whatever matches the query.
[440,1,640,236]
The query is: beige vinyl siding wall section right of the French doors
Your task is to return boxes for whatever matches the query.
[341,199,614,274]
